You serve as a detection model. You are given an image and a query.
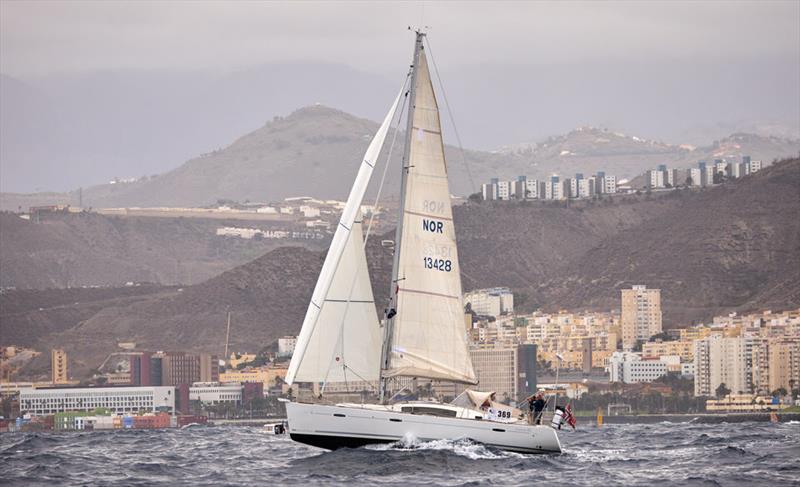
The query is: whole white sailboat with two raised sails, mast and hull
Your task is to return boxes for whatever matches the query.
[286,31,561,453]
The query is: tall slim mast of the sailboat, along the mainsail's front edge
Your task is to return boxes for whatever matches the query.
[380,30,425,403]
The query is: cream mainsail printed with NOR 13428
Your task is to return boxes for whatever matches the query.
[383,48,477,384]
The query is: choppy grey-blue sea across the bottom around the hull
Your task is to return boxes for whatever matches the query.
[0,421,800,486]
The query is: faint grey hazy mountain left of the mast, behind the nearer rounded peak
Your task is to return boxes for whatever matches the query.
[0,62,397,192]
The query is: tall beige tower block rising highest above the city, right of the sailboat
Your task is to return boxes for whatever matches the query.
[621,285,661,350]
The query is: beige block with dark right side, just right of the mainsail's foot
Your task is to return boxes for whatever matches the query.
[470,344,536,402]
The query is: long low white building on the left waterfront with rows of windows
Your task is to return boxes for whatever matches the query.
[19,386,175,416]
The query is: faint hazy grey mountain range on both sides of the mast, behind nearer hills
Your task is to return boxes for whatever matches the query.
[0,54,800,193]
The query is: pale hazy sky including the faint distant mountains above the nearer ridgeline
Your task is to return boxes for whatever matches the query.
[0,1,800,192]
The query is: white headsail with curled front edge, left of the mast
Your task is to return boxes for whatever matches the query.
[286,86,403,385]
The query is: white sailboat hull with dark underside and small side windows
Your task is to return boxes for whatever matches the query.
[286,402,561,453]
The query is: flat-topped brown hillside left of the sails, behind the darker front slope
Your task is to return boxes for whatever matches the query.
[0,212,327,289]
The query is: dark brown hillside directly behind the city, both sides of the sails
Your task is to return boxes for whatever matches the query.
[0,159,800,382]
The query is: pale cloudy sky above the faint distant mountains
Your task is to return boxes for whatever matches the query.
[0,0,800,77]
